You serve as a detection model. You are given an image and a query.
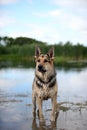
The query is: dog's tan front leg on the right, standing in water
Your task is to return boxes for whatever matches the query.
[51,95,57,121]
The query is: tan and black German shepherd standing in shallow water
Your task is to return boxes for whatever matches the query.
[32,47,58,121]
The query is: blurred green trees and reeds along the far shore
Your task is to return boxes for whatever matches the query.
[0,36,87,67]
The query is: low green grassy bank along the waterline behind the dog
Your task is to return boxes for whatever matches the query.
[0,55,87,68]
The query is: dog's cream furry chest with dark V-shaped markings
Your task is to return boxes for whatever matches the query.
[34,74,56,100]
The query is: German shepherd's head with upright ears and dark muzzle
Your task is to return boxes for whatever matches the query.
[35,47,54,73]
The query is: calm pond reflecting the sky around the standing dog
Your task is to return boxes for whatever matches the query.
[0,68,87,130]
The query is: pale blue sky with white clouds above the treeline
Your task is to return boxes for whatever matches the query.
[0,0,87,46]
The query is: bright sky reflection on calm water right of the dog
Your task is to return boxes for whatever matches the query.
[57,69,87,102]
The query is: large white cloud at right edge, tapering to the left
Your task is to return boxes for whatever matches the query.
[33,7,87,31]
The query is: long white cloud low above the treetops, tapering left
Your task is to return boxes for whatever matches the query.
[6,23,60,43]
